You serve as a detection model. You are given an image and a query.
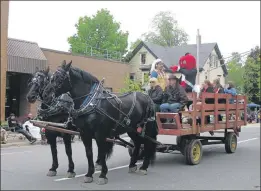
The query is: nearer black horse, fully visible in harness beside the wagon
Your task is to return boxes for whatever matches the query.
[43,61,157,184]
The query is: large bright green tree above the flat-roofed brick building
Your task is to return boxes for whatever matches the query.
[68,9,129,57]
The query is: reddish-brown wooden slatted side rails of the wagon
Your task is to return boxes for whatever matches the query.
[156,93,247,136]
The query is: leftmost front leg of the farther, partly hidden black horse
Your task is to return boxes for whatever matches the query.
[46,133,59,176]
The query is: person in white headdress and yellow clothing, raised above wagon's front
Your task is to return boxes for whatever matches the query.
[150,59,167,90]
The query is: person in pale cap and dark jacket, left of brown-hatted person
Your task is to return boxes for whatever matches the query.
[148,78,163,112]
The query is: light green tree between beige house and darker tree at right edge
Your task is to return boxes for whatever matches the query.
[227,52,244,93]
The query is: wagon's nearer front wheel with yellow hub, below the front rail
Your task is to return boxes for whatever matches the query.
[185,139,203,165]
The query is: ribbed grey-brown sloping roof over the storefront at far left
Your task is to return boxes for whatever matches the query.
[7,38,47,60]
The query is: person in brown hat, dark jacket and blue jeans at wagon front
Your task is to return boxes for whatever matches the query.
[160,74,189,113]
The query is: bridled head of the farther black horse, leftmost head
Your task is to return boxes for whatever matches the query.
[26,66,50,103]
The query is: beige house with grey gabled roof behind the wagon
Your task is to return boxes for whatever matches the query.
[129,42,228,84]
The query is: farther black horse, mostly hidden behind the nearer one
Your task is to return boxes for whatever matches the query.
[26,67,101,178]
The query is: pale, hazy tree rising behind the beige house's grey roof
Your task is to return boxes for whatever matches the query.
[143,11,188,47]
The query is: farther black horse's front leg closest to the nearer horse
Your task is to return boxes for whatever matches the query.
[63,134,76,178]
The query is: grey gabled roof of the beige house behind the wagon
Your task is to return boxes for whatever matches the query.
[130,42,227,75]
